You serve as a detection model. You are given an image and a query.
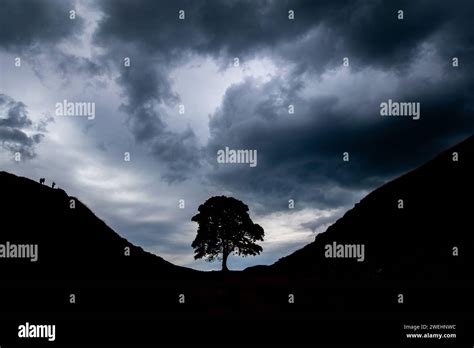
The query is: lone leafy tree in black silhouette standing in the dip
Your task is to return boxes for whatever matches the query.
[191,196,264,271]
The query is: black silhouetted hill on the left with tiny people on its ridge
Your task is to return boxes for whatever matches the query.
[0,171,193,280]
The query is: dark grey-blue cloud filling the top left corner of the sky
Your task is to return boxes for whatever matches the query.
[0,0,105,89]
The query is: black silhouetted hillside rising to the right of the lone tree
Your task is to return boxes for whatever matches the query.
[262,136,474,283]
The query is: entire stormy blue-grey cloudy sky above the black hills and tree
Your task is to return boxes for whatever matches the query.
[0,0,474,269]
